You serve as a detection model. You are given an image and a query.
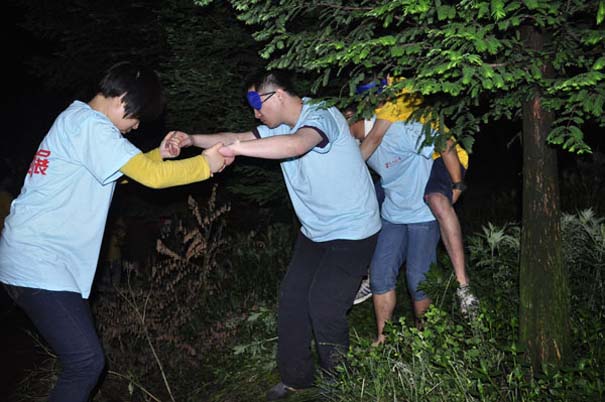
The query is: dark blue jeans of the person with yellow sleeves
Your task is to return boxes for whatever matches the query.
[4,284,105,402]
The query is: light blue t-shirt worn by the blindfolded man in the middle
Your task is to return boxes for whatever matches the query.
[255,98,381,242]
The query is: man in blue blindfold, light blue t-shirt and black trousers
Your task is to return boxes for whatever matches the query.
[175,72,381,400]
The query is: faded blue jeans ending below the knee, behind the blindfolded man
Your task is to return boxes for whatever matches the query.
[370,219,439,301]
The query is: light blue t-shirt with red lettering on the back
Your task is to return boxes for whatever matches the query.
[0,101,141,298]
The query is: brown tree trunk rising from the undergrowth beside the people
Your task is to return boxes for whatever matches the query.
[519,27,570,371]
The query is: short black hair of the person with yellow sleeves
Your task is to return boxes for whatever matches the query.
[98,61,165,121]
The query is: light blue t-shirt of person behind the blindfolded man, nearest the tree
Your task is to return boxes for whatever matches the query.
[368,122,435,224]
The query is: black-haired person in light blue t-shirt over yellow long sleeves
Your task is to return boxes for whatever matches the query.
[0,62,229,402]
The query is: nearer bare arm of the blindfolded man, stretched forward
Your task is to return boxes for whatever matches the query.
[221,127,323,159]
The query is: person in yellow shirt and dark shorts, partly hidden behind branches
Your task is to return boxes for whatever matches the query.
[357,80,478,315]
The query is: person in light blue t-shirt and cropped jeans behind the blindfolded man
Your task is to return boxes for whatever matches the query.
[351,114,439,344]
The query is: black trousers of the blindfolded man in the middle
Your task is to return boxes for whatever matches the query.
[277,233,377,388]
